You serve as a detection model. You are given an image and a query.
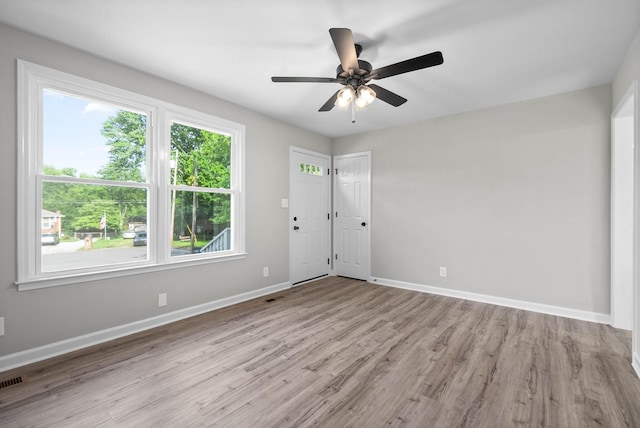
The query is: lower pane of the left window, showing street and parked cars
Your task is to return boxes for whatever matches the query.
[39,181,147,272]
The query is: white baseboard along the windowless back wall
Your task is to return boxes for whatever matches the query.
[369,277,611,324]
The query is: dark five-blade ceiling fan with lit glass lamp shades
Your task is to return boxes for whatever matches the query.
[271,28,444,122]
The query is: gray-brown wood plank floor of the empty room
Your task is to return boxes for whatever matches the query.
[0,278,640,428]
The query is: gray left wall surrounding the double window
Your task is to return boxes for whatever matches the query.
[0,24,331,356]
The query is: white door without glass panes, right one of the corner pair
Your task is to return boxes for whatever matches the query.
[333,152,371,281]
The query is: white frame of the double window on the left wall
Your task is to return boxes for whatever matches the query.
[16,60,246,290]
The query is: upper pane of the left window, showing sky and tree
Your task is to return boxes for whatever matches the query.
[42,90,147,183]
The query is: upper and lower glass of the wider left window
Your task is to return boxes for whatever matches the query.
[36,88,147,273]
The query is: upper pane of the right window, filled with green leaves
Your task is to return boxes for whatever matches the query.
[170,122,231,189]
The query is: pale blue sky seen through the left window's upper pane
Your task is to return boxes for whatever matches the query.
[43,90,118,175]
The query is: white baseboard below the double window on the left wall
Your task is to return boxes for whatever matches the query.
[0,282,291,372]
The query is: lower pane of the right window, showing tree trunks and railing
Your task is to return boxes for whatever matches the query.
[171,191,231,256]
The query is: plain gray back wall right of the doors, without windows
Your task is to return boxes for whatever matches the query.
[334,85,611,314]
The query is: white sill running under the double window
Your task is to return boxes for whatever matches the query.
[15,253,247,291]
